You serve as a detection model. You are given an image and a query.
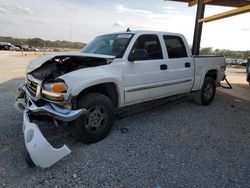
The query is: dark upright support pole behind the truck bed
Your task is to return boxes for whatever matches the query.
[192,0,205,55]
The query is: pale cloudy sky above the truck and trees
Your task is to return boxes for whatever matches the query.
[0,0,250,50]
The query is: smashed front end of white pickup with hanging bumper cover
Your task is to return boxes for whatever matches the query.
[15,54,113,168]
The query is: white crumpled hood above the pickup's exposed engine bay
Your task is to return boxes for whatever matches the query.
[26,52,115,73]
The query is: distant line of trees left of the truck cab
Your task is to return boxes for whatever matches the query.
[0,36,86,49]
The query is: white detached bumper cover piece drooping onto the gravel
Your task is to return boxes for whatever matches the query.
[23,110,71,168]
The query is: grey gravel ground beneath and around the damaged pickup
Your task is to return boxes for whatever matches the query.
[0,51,250,188]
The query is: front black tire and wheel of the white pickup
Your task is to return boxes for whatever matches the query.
[71,93,114,144]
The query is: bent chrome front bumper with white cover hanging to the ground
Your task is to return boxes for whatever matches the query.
[15,86,86,168]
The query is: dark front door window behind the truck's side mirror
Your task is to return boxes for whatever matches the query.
[131,35,163,60]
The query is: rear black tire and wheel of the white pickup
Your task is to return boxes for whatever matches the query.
[193,77,216,106]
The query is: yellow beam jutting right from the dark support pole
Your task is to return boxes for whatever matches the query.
[199,5,250,22]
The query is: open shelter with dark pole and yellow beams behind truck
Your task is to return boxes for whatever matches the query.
[165,0,250,55]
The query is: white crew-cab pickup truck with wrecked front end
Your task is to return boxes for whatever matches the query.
[16,31,226,168]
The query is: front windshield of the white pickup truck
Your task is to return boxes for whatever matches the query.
[81,33,133,58]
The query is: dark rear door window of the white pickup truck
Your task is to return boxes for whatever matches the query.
[163,36,187,59]
